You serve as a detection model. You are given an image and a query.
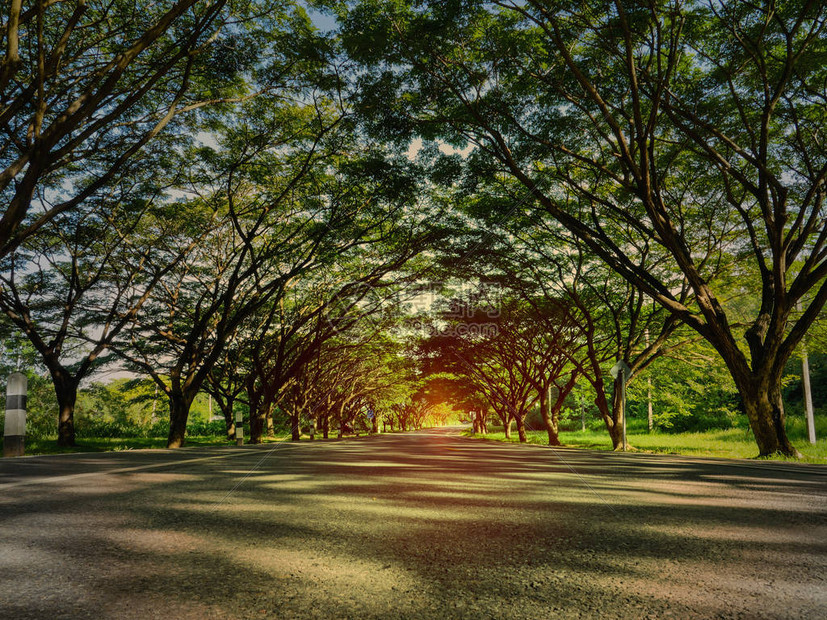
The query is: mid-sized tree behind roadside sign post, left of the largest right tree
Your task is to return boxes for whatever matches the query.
[510,230,686,450]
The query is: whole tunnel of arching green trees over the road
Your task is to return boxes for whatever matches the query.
[0,0,827,456]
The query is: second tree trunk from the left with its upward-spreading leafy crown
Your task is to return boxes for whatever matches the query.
[115,114,342,447]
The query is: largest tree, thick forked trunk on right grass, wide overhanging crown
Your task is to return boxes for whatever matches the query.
[327,0,827,455]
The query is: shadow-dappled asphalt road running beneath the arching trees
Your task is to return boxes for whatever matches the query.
[0,429,827,620]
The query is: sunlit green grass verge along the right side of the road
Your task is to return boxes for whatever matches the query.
[463,428,827,465]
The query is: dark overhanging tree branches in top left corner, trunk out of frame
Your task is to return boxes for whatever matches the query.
[0,0,246,256]
